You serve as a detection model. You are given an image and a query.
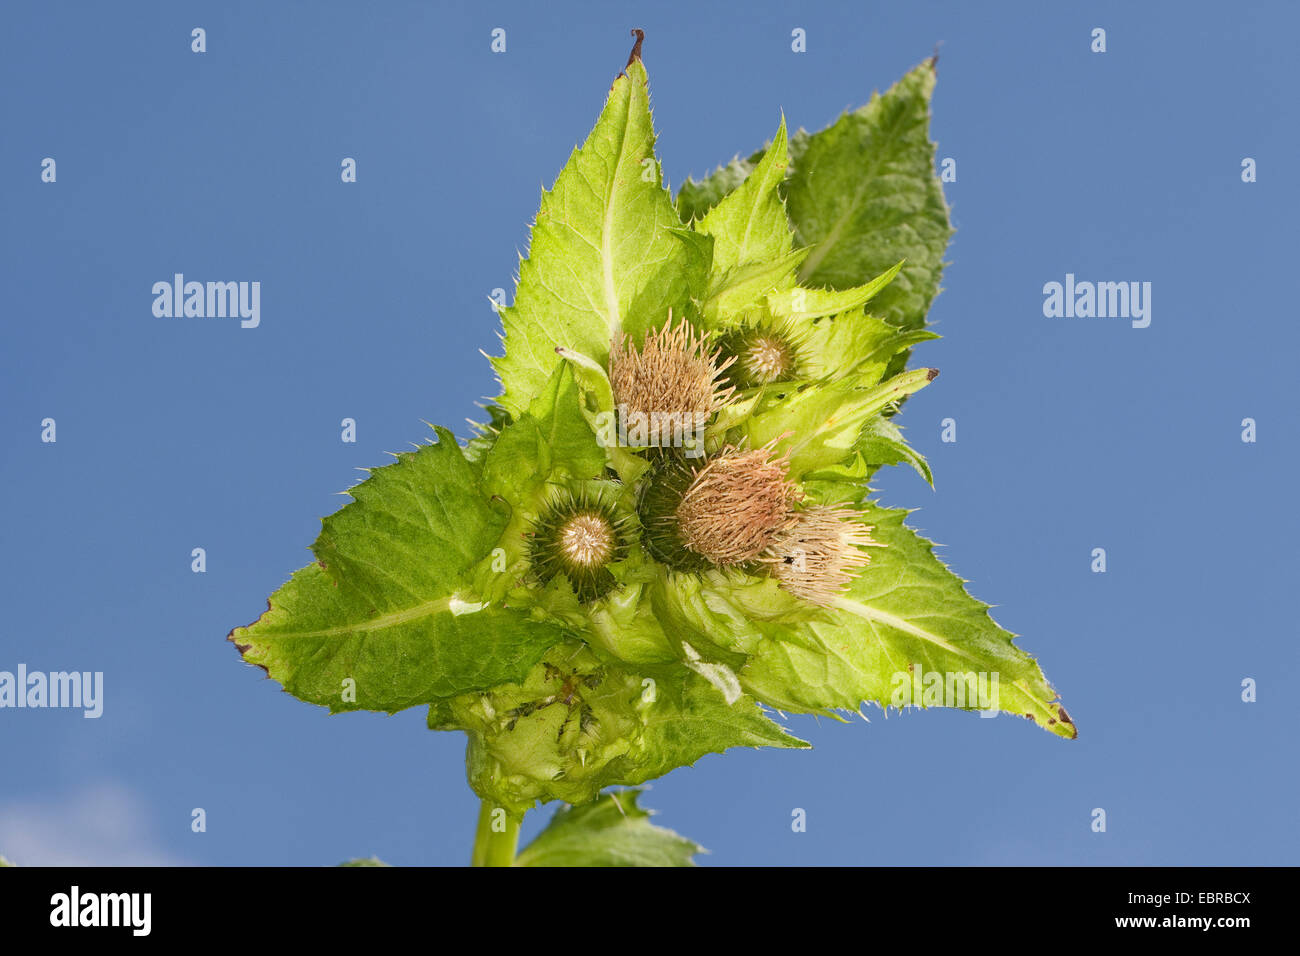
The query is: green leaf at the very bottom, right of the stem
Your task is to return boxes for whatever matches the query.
[515,790,705,866]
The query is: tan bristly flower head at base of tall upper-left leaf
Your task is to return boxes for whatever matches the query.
[610,310,732,445]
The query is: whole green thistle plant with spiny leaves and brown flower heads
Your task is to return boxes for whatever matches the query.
[230,39,1075,865]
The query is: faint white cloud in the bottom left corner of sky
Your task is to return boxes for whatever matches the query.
[0,783,185,866]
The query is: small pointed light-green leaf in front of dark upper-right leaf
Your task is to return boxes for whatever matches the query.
[696,116,792,274]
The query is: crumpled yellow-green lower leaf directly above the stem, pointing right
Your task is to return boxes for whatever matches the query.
[429,644,806,813]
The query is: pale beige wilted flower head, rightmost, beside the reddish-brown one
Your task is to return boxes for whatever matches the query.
[763,505,884,607]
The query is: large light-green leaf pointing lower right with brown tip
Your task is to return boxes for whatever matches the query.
[740,502,1076,739]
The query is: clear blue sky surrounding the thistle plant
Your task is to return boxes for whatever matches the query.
[0,1,1300,865]
